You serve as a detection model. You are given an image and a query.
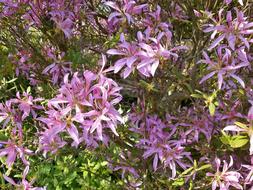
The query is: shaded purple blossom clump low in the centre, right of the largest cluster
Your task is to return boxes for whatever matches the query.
[131,115,191,178]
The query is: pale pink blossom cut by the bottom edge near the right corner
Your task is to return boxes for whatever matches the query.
[206,156,243,190]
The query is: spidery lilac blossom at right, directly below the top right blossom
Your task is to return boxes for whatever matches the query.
[199,46,249,89]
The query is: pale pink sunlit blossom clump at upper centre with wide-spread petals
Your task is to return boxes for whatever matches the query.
[107,33,185,78]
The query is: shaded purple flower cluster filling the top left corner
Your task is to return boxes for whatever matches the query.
[0,0,85,38]
